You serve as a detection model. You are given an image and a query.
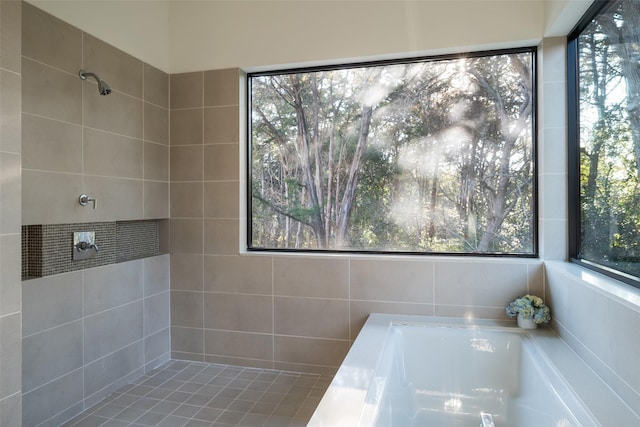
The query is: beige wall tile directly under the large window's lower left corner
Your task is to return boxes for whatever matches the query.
[204,255,272,295]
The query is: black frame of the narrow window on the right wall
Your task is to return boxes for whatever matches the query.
[567,0,640,288]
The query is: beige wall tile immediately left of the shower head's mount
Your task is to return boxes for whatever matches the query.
[22,58,82,124]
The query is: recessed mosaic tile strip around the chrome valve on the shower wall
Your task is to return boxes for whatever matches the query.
[22,220,160,280]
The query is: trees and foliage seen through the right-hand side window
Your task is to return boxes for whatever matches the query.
[579,2,640,277]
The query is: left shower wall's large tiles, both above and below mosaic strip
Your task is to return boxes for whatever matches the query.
[20,1,170,427]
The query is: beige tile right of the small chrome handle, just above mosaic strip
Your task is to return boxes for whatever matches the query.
[84,175,144,221]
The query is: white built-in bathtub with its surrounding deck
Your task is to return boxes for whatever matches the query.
[308,314,640,427]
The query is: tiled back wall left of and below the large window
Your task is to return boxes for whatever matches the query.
[170,69,543,373]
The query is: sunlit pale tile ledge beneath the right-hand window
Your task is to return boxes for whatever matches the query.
[544,261,640,312]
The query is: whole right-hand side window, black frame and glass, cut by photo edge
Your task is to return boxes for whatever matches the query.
[568,0,640,287]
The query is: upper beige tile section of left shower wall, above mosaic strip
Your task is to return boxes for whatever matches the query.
[22,3,169,225]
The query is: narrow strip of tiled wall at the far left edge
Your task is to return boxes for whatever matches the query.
[0,0,22,427]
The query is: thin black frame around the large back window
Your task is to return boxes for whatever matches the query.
[244,46,540,259]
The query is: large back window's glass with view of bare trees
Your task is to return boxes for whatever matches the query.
[247,48,537,256]
